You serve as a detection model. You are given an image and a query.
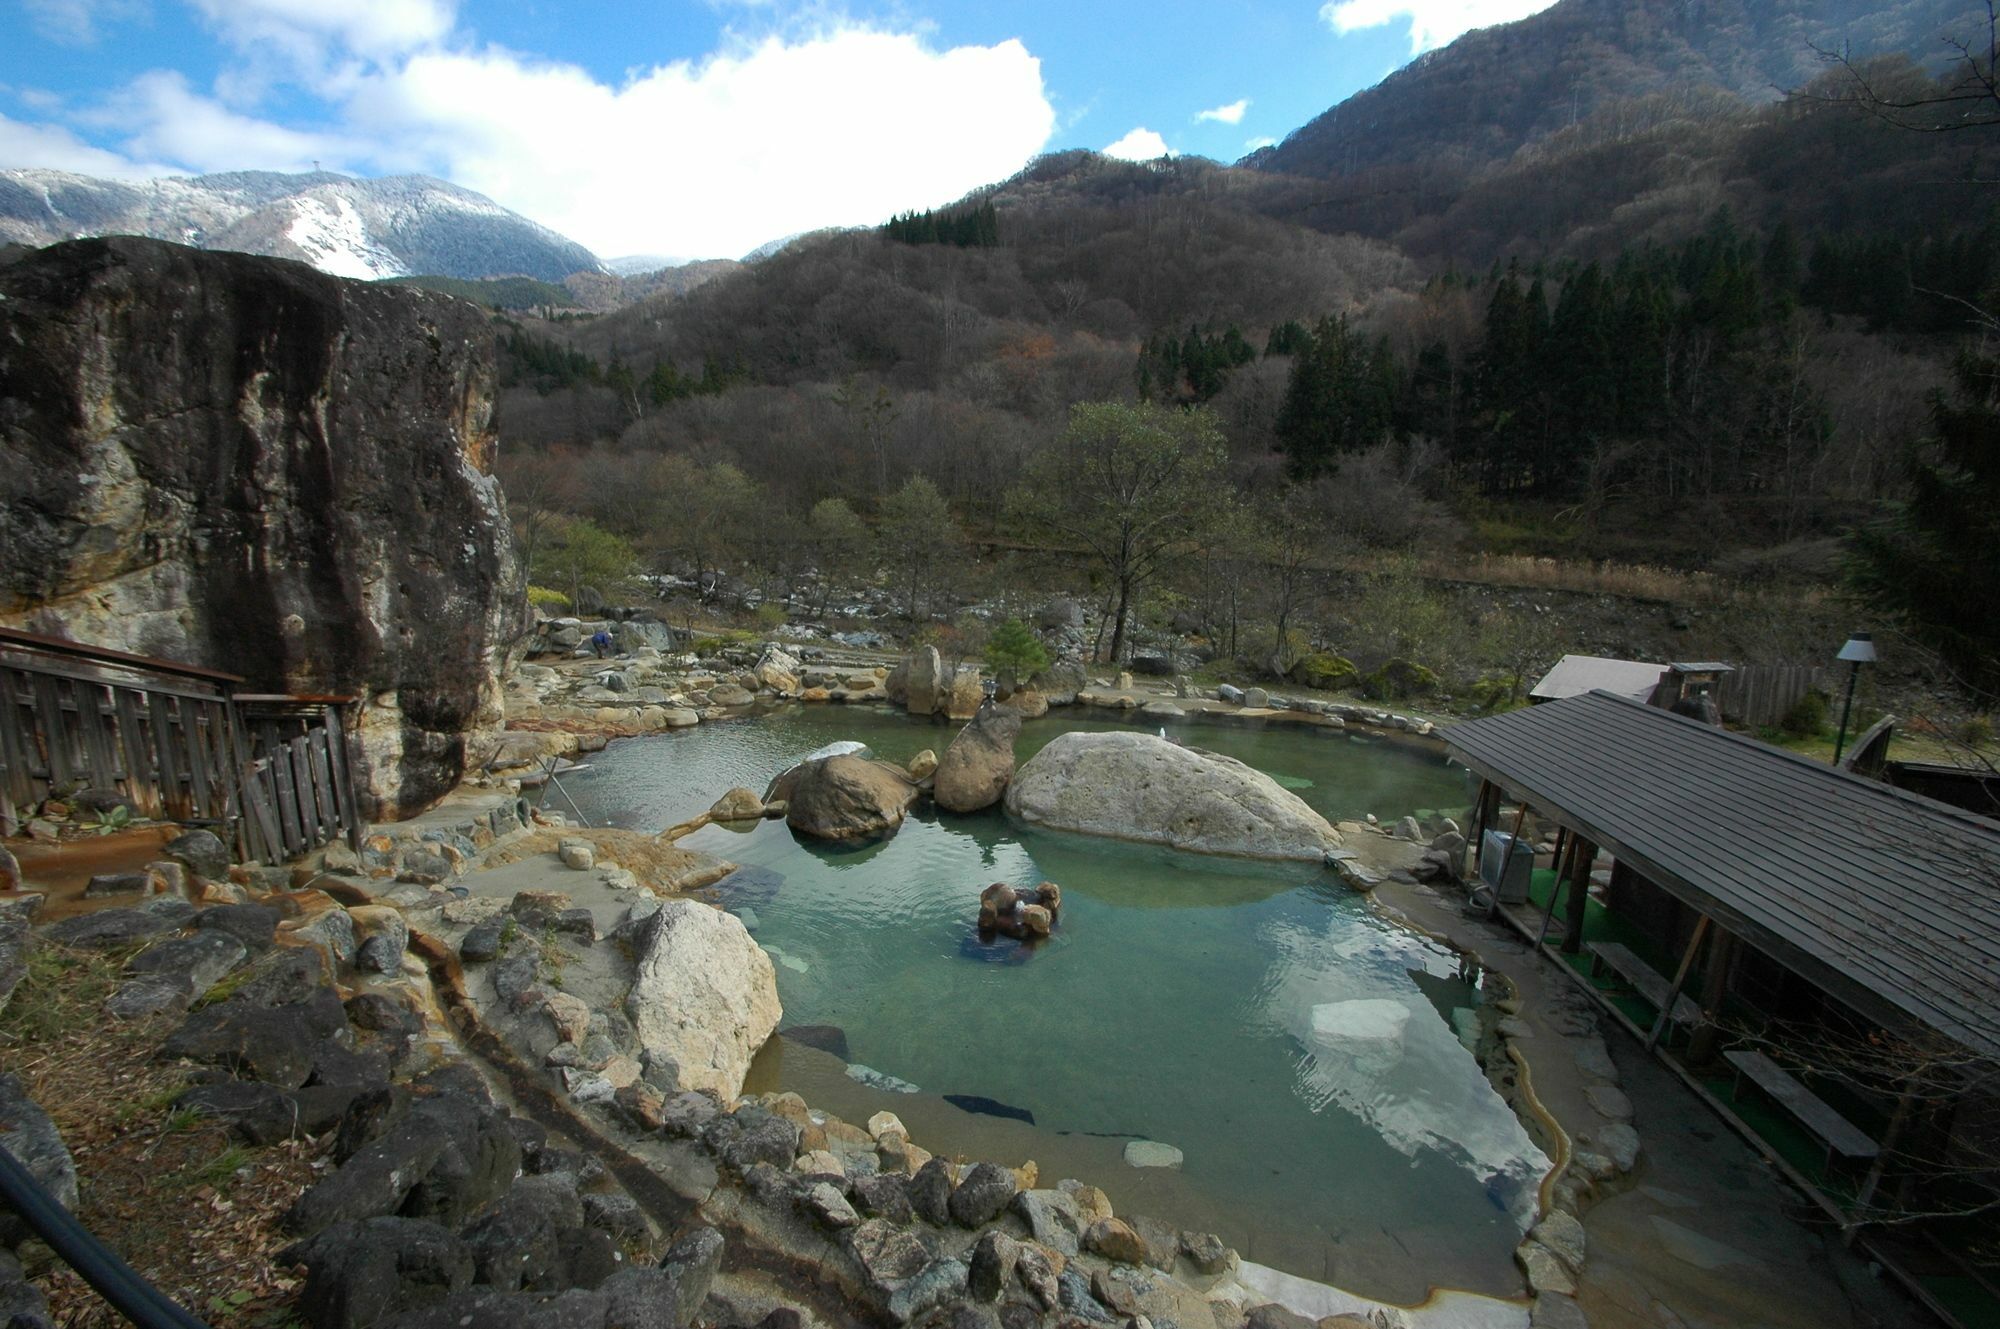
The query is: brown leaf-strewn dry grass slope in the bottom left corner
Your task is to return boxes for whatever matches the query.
[0,945,318,1329]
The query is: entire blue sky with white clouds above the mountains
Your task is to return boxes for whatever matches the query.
[0,0,1550,258]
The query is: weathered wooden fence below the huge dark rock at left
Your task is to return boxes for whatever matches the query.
[0,628,366,863]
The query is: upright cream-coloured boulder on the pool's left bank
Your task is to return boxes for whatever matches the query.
[626,901,784,1099]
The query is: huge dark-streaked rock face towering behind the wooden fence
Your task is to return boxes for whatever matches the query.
[0,238,526,819]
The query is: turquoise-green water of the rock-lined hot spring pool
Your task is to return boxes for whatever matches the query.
[566,707,1546,1301]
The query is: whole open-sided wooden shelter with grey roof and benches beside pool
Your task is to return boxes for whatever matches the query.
[1444,691,2000,1320]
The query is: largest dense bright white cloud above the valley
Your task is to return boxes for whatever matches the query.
[348,28,1054,256]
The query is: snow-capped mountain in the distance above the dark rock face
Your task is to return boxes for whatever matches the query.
[0,170,604,282]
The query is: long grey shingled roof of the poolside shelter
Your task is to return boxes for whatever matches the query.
[1444,693,2000,1055]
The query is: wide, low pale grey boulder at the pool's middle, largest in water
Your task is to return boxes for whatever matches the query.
[1006,733,1340,861]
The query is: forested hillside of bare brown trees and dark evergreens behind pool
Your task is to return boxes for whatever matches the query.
[488,0,2000,704]
